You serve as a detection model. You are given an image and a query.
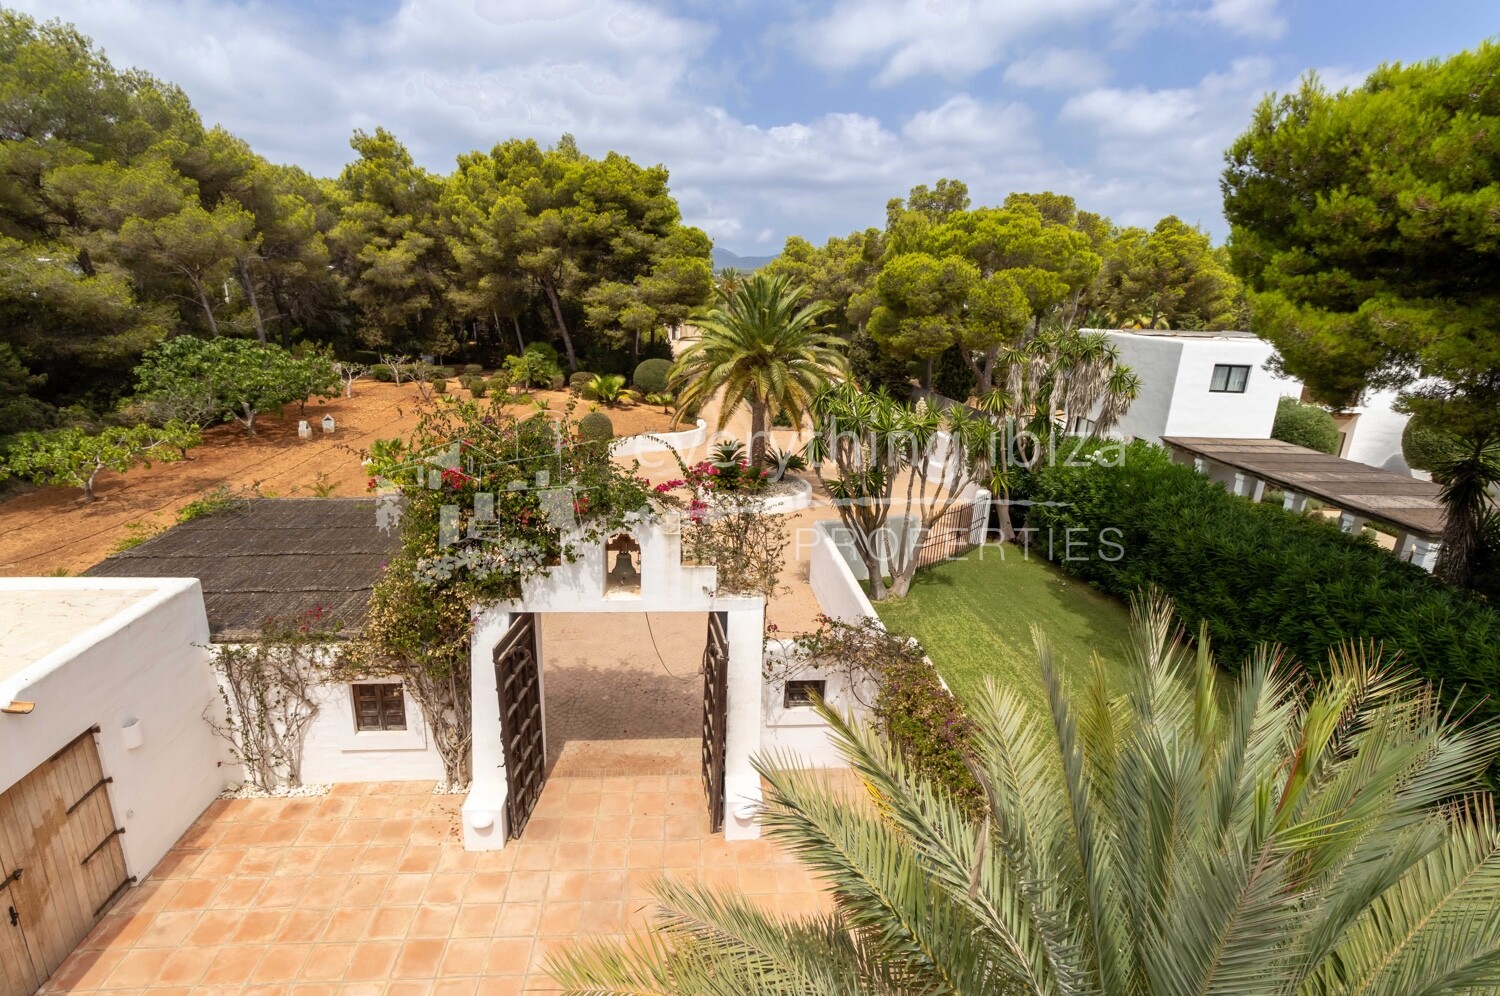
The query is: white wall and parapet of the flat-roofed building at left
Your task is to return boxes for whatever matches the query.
[0,578,231,878]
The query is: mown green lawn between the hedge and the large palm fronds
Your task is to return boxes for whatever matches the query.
[875,546,1130,705]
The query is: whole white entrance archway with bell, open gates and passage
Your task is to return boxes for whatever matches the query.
[464,524,765,851]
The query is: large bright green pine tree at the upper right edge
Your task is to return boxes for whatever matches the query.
[1224,42,1500,587]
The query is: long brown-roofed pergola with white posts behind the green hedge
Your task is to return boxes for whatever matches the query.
[1161,437,1443,570]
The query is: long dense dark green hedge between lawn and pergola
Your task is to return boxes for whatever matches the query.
[1028,443,1500,717]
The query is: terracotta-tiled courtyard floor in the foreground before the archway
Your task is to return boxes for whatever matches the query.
[44,741,827,996]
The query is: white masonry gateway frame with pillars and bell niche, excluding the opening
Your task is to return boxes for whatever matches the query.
[464,522,765,851]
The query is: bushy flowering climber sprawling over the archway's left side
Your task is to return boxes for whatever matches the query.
[351,399,653,783]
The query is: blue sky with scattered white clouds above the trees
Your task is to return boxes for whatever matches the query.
[14,0,1500,255]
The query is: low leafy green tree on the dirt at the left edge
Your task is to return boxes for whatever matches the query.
[0,422,203,501]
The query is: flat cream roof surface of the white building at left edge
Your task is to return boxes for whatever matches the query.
[0,582,162,681]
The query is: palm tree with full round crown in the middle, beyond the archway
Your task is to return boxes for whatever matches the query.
[668,273,846,467]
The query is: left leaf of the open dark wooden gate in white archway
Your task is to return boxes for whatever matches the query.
[495,612,548,839]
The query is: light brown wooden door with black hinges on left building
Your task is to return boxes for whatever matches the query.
[0,726,135,996]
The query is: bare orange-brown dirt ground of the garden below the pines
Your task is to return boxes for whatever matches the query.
[0,381,672,576]
